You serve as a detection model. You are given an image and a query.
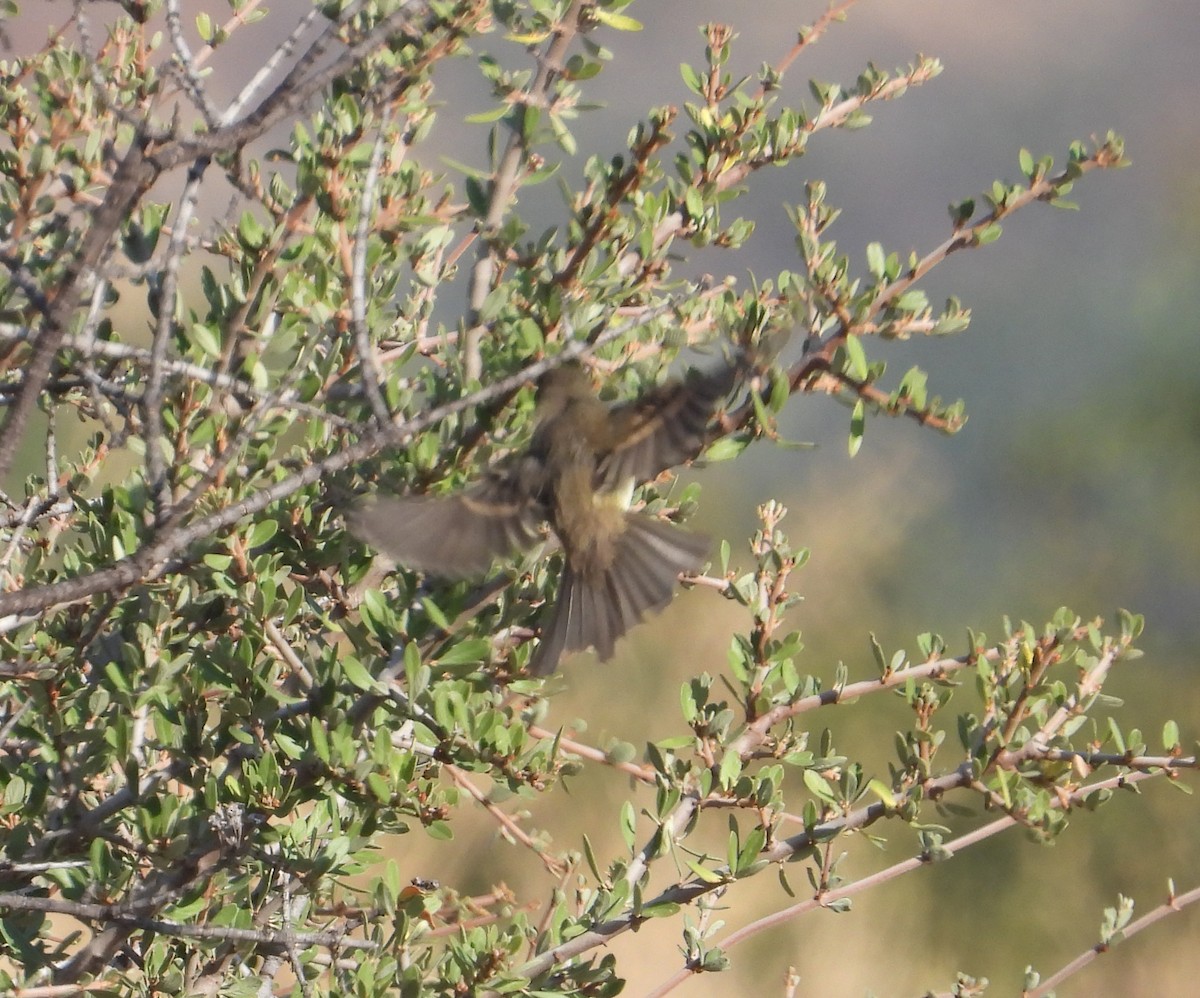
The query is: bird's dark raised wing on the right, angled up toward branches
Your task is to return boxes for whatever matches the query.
[596,363,742,489]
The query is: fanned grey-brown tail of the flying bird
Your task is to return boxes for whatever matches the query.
[529,513,709,675]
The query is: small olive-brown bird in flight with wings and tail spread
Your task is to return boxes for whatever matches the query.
[349,359,744,675]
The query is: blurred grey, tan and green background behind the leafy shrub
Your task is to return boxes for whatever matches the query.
[11,0,1200,998]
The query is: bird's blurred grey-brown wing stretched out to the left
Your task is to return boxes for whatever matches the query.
[349,469,546,578]
